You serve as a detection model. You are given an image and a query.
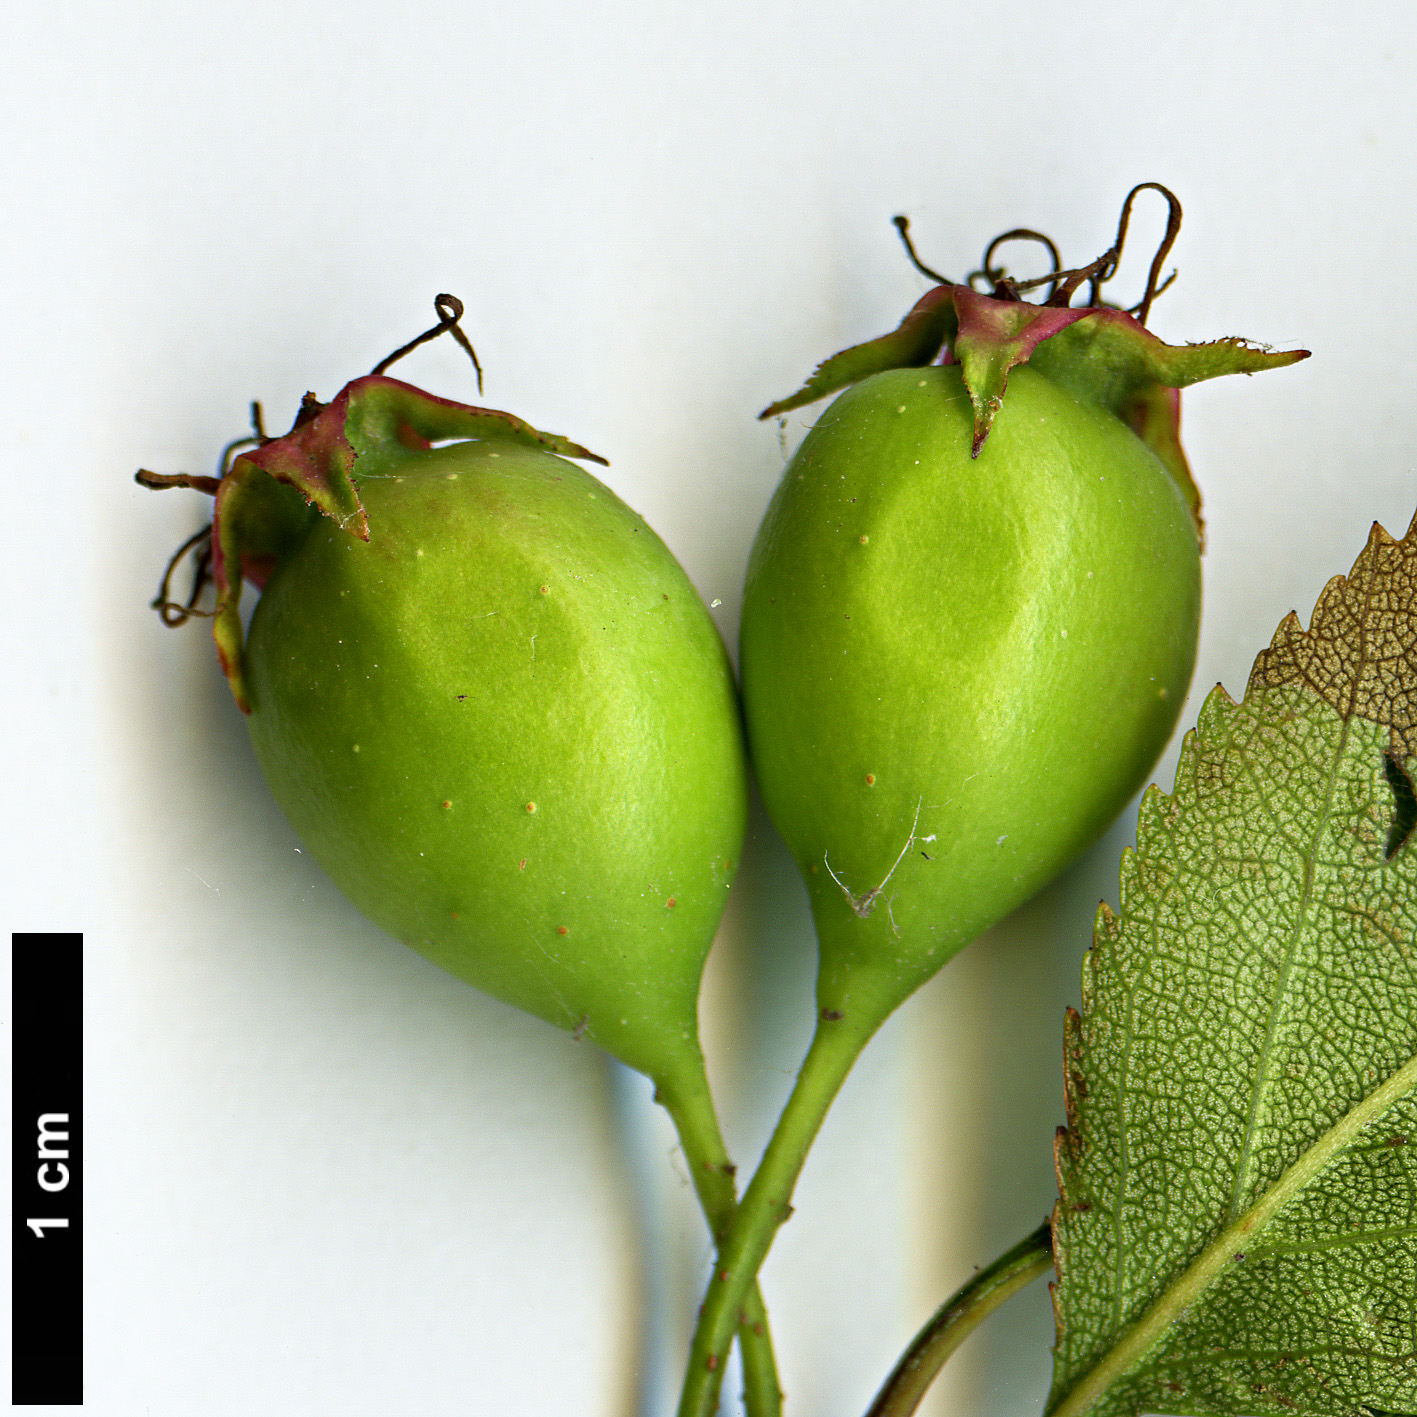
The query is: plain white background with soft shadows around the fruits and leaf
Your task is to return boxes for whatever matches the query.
[8,0,1417,1417]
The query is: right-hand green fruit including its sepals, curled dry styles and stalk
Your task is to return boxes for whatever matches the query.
[668,209,1305,1417]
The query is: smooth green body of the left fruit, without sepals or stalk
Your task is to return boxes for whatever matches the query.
[245,441,747,1081]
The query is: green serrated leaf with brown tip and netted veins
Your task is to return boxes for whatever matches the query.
[1047,519,1417,1417]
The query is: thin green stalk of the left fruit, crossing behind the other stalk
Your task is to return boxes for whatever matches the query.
[655,1066,782,1417]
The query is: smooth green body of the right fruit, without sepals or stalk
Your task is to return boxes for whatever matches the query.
[741,366,1200,1026]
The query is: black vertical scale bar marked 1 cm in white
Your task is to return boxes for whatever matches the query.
[10,934,84,1407]
